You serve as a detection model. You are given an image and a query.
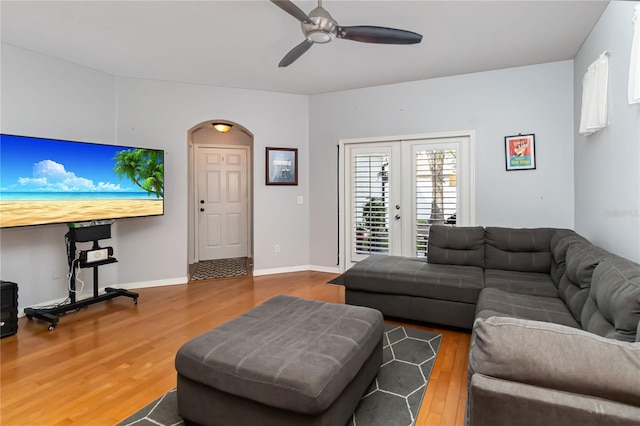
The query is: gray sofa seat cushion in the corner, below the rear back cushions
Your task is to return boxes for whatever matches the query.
[484,269,558,297]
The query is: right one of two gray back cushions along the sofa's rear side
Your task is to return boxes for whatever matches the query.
[485,227,554,274]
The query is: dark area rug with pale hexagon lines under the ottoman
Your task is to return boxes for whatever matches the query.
[118,324,442,426]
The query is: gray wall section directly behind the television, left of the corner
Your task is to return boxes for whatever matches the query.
[0,44,117,308]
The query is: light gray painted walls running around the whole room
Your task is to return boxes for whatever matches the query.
[0,2,640,308]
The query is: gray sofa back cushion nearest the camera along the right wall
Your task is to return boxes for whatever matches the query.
[581,255,640,342]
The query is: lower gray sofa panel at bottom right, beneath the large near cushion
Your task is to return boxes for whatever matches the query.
[466,374,640,426]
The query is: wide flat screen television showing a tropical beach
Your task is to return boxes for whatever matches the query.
[0,134,164,228]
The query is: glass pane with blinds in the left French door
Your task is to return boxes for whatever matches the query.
[351,153,389,254]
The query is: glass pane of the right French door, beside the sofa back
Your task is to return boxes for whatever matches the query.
[415,149,458,256]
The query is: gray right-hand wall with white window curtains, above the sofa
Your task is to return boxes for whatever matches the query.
[574,1,640,262]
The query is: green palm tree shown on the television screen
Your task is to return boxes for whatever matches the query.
[113,148,164,198]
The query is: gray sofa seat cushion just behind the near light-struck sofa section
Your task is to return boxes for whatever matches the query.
[476,288,580,328]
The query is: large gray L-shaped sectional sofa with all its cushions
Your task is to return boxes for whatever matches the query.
[344,225,640,425]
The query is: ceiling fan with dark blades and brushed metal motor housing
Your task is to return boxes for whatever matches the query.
[271,0,422,67]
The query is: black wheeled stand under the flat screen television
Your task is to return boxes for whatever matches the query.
[24,224,139,330]
